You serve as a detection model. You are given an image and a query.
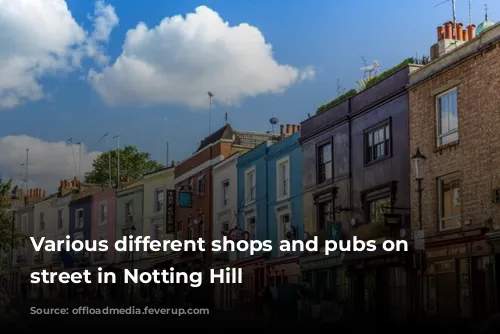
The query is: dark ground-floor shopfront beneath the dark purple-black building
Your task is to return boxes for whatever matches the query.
[343,247,413,323]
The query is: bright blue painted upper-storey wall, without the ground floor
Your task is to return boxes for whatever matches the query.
[237,132,304,258]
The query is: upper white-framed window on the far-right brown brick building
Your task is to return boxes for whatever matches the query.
[436,89,458,146]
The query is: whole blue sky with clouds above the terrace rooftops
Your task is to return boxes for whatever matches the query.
[0,0,500,190]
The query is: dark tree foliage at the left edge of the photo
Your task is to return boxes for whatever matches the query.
[0,180,23,251]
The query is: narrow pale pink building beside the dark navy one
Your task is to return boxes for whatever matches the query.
[90,189,116,266]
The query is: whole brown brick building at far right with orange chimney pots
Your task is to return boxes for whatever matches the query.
[409,22,500,321]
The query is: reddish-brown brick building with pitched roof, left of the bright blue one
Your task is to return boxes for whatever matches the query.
[174,124,280,269]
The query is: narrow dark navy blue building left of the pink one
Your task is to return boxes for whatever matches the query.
[69,196,92,264]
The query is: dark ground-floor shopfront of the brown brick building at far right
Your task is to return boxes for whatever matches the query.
[424,240,494,323]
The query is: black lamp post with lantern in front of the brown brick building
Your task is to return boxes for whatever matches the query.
[411,148,427,320]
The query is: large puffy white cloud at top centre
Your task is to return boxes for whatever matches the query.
[89,6,314,108]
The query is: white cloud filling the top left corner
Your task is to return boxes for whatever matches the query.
[0,0,118,109]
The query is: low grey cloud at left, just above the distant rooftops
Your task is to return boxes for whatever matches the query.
[0,135,100,191]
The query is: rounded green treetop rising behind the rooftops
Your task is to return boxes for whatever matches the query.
[85,145,163,187]
